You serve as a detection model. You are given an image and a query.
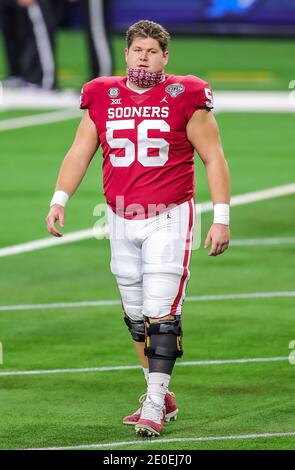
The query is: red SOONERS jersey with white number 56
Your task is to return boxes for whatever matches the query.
[81,75,213,219]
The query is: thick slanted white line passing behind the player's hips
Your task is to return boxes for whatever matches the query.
[0,183,295,257]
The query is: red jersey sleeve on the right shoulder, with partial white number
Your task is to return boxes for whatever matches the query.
[185,77,213,121]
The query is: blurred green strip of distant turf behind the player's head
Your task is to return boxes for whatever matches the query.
[58,32,295,90]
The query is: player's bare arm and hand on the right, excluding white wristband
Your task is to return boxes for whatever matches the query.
[186,109,230,256]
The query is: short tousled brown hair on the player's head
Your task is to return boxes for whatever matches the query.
[126,20,170,52]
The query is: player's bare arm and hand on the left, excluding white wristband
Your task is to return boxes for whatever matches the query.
[46,110,99,237]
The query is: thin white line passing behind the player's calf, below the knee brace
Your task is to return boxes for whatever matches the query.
[0,356,288,377]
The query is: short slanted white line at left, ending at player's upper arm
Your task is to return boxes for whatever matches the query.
[0,109,82,132]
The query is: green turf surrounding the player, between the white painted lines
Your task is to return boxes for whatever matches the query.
[0,33,295,450]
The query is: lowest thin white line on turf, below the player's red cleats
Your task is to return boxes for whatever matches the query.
[27,432,295,450]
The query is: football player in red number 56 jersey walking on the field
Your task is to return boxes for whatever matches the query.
[47,20,230,436]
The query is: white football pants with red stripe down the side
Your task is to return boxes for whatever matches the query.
[108,199,195,320]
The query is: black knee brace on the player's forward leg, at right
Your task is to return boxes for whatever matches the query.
[144,316,183,360]
